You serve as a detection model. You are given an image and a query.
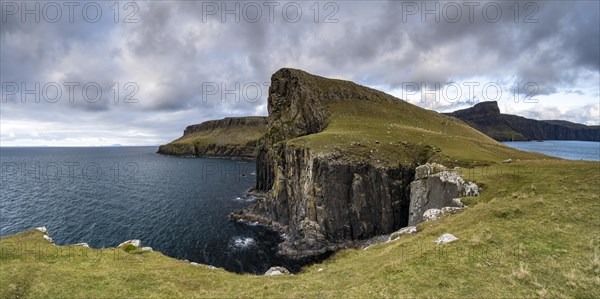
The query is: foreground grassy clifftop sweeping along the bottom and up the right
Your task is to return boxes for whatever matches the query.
[0,159,600,298]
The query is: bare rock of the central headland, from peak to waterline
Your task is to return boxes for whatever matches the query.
[231,69,414,257]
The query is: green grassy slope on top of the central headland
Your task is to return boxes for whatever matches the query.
[290,100,546,166]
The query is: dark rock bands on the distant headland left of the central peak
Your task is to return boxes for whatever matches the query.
[158,116,268,158]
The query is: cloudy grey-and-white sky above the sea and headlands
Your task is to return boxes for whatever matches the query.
[0,1,600,146]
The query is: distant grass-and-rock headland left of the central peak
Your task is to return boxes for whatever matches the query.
[158,116,267,158]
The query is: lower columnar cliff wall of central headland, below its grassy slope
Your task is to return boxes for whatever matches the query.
[237,145,414,257]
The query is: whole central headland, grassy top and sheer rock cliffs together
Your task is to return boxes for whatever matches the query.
[231,69,540,256]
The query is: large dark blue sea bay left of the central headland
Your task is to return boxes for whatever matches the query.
[0,147,306,274]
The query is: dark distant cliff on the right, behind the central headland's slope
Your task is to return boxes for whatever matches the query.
[447,102,600,141]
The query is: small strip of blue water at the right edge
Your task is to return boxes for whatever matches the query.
[503,140,600,161]
